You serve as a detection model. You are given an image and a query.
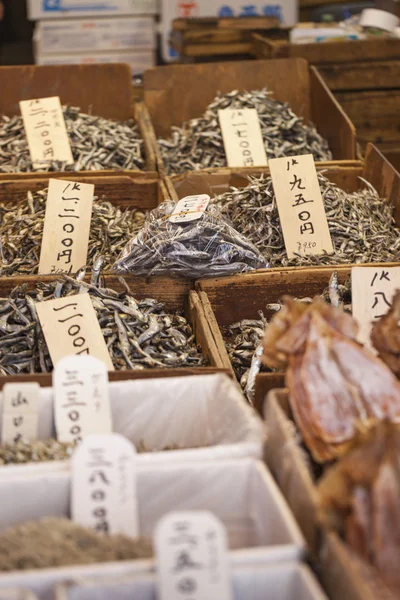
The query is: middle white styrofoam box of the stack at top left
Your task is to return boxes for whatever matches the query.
[34,16,156,54]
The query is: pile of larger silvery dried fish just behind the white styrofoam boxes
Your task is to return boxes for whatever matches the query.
[0,275,205,375]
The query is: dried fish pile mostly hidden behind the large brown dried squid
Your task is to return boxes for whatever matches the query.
[227,272,351,401]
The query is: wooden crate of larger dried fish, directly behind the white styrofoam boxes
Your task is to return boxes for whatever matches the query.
[0,273,227,389]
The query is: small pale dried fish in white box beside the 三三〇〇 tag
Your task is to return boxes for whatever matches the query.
[0,439,75,465]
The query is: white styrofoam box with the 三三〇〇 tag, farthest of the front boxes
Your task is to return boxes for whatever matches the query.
[0,374,264,476]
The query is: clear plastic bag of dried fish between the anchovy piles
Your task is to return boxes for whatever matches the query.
[113,201,268,279]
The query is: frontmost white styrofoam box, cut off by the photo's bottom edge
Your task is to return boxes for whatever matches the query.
[55,562,327,600]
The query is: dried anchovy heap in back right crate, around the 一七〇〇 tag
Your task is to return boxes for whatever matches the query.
[158,88,332,174]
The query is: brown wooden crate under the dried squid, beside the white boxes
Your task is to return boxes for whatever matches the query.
[264,389,395,600]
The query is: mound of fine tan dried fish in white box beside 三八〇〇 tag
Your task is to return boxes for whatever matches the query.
[0,517,153,571]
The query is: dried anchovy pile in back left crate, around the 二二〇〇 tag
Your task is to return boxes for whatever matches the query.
[0,106,145,173]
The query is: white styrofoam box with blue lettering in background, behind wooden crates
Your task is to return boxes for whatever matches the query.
[160,0,299,61]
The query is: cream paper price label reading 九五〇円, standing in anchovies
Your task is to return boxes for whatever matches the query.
[268,154,333,258]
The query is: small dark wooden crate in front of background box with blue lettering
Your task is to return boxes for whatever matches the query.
[170,17,279,62]
